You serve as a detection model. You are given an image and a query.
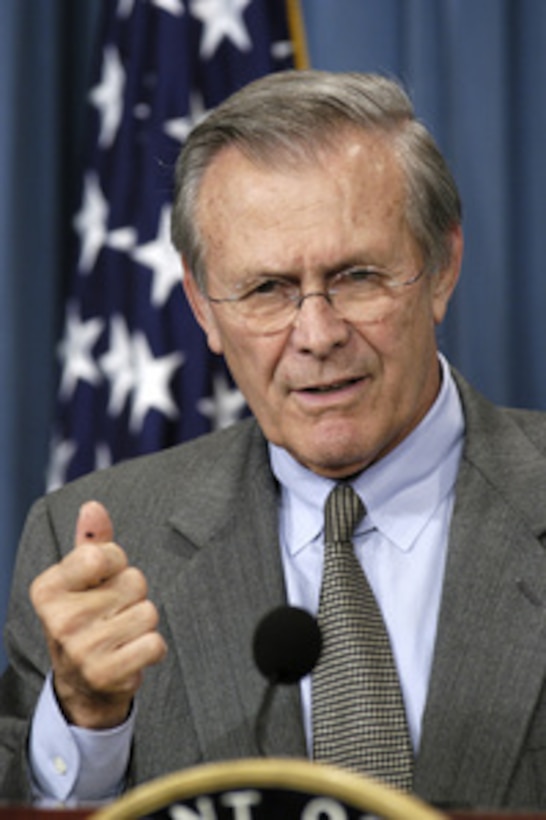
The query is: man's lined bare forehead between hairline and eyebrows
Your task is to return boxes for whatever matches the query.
[196,132,405,274]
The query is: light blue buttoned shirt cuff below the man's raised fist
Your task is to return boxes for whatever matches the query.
[28,673,136,806]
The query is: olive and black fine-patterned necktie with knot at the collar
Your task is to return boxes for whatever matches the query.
[312,484,413,791]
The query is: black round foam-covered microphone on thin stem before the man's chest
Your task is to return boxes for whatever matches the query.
[253,606,322,757]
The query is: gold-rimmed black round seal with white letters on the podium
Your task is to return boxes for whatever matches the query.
[91,758,447,820]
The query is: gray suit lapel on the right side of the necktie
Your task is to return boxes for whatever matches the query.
[416,378,546,806]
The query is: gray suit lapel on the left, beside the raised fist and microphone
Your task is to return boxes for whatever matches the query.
[157,436,305,757]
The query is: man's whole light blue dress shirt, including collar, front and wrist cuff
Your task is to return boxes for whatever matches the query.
[29,356,464,805]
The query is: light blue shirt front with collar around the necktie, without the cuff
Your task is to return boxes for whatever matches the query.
[270,357,464,750]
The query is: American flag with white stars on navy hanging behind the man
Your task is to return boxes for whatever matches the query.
[47,0,305,489]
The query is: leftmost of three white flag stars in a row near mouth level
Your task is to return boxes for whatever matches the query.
[58,303,104,399]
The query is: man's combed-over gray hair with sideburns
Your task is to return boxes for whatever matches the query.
[172,70,462,288]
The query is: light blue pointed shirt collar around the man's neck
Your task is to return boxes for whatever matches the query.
[269,355,464,553]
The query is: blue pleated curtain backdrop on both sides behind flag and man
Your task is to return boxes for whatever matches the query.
[0,0,546,664]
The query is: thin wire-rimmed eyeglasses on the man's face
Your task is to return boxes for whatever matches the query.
[207,267,426,335]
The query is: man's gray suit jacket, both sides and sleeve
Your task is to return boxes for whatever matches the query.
[0,376,546,809]
